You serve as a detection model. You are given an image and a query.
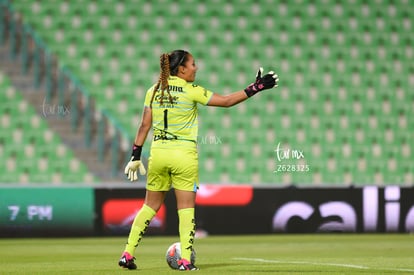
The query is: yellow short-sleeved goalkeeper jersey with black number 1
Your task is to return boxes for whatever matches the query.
[144,76,213,147]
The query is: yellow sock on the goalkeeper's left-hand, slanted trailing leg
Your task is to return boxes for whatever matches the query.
[125,204,156,256]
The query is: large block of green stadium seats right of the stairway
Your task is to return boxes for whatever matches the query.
[9,0,414,185]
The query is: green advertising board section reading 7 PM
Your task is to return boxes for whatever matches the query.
[0,187,94,236]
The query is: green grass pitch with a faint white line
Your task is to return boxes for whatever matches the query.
[0,234,414,274]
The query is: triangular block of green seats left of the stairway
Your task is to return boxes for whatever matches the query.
[0,72,96,184]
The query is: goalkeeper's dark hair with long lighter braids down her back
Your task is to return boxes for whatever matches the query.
[150,50,189,107]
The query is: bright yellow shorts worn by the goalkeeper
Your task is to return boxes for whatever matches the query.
[146,147,199,192]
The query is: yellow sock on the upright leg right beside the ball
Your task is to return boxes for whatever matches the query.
[178,208,196,262]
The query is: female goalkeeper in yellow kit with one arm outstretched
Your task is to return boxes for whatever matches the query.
[119,50,278,270]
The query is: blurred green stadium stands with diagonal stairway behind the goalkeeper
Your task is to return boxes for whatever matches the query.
[0,0,414,187]
